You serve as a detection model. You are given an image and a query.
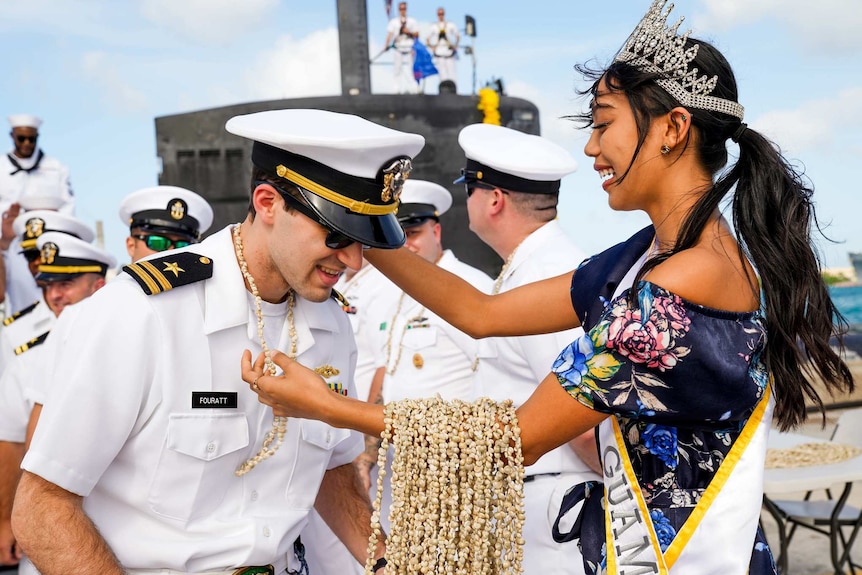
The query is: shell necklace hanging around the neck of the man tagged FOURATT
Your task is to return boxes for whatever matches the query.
[232,225,297,477]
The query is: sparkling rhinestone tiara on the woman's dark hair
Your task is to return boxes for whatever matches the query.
[614,0,745,120]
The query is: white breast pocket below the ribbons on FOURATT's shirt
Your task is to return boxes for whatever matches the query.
[287,419,350,509]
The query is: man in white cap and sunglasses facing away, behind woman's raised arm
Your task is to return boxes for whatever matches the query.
[456,124,599,575]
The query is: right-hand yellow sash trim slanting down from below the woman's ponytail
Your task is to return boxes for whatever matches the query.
[664,376,772,567]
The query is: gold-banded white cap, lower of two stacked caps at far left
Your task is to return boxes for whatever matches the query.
[36,232,117,282]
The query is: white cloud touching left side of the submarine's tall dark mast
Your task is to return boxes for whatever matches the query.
[244,28,341,99]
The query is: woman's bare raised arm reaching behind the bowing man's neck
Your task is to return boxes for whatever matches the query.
[365,248,580,338]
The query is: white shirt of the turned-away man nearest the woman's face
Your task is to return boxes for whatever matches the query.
[474,220,589,475]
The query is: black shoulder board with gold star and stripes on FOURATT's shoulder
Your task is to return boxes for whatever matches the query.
[123,252,213,295]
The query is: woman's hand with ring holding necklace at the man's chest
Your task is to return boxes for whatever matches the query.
[242,350,335,420]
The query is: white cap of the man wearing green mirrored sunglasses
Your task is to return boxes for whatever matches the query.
[120,186,213,242]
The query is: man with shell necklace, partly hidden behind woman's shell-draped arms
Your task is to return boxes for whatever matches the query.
[359,180,493,529]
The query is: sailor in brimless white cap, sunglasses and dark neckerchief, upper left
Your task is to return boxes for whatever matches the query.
[0,114,75,214]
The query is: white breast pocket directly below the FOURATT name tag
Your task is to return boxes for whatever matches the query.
[149,413,249,521]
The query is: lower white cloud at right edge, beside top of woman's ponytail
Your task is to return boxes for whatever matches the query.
[752,87,862,155]
